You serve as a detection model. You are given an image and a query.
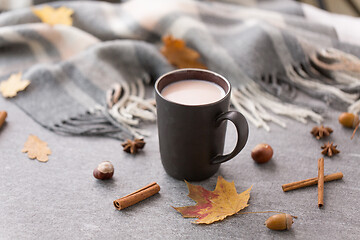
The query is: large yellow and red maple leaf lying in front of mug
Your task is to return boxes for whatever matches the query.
[174,176,252,224]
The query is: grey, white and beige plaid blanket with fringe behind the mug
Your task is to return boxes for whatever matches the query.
[0,0,360,139]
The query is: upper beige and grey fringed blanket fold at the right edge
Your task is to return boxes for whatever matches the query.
[257,49,360,111]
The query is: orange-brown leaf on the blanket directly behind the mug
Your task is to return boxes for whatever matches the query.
[161,35,207,69]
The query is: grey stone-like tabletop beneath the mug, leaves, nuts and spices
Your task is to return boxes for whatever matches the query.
[0,90,360,239]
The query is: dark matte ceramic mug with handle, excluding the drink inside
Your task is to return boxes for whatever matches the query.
[155,69,249,181]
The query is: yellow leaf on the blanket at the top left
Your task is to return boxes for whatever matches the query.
[32,6,74,26]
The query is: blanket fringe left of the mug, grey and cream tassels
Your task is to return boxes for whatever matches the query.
[53,80,156,140]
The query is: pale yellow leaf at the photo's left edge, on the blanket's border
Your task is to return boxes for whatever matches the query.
[0,72,30,98]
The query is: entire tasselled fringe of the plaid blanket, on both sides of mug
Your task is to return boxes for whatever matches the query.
[55,49,360,137]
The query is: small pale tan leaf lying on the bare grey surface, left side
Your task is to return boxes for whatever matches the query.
[21,135,51,162]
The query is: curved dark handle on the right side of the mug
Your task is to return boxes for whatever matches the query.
[211,111,249,164]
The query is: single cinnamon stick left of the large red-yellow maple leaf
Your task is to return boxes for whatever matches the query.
[114,182,160,210]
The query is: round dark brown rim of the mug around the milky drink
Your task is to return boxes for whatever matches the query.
[155,68,231,107]
